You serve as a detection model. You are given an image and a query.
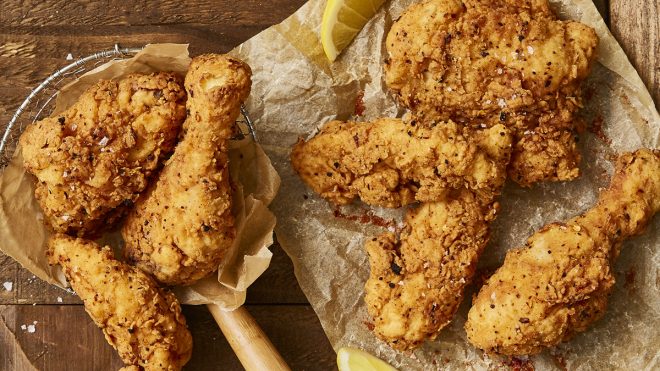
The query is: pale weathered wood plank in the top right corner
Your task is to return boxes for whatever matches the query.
[610,0,660,107]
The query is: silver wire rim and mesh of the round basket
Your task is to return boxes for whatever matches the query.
[0,44,257,169]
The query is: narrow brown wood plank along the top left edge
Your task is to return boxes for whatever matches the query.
[0,0,305,27]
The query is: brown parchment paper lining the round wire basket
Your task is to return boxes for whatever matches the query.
[0,44,280,310]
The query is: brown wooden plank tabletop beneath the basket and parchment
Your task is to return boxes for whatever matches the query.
[0,0,660,370]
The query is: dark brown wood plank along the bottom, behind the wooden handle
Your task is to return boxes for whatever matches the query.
[0,305,335,371]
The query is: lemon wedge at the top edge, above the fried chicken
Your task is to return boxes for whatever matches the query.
[321,0,385,62]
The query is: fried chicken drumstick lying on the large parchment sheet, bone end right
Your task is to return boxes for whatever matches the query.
[465,149,660,355]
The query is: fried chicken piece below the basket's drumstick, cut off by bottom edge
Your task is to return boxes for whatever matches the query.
[48,235,192,371]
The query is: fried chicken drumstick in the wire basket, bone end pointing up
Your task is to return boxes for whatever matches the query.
[122,54,251,285]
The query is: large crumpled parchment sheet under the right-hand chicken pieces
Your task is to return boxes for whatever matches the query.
[229,0,660,370]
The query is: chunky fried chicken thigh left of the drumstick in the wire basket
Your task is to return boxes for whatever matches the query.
[20,72,186,236]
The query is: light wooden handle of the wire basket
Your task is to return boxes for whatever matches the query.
[207,304,291,371]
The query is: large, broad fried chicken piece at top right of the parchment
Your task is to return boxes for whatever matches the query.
[385,0,598,186]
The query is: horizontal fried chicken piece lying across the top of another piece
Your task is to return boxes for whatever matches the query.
[291,119,511,207]
